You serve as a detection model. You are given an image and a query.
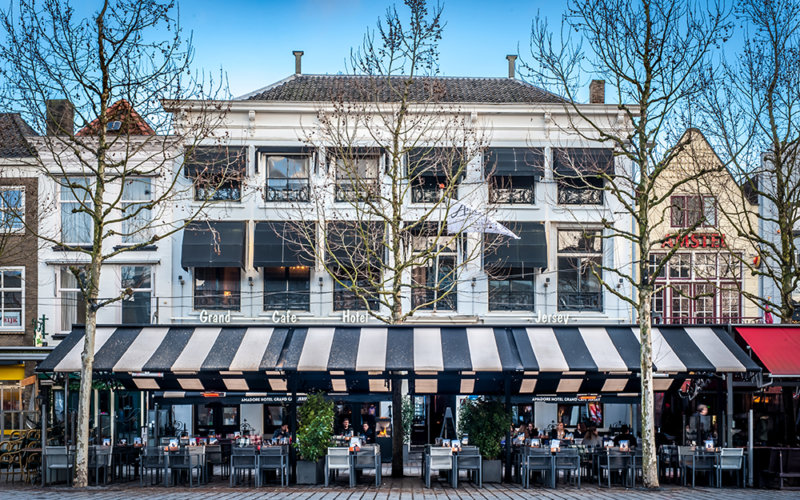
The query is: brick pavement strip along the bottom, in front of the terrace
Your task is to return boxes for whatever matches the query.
[0,478,800,500]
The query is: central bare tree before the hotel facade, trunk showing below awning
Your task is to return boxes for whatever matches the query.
[276,0,492,476]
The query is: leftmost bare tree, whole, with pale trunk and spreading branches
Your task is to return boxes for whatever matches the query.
[0,0,231,486]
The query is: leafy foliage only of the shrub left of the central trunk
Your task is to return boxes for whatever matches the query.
[294,393,334,462]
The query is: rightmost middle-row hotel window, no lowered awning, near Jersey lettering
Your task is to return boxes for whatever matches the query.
[558,229,603,311]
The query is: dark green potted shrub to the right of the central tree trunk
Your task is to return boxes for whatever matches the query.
[458,398,511,483]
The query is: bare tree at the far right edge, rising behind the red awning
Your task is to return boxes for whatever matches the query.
[696,0,800,321]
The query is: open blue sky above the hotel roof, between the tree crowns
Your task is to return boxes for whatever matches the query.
[180,0,564,96]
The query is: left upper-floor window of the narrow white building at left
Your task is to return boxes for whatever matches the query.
[60,177,93,245]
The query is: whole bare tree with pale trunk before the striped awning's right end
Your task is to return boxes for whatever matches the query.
[526,0,728,488]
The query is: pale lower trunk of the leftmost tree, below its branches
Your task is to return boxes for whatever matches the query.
[73,307,97,488]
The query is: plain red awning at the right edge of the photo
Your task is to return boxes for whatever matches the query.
[736,326,800,376]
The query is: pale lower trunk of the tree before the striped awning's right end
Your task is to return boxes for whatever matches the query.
[638,289,659,488]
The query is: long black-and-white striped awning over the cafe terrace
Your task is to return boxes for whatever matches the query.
[37,325,759,394]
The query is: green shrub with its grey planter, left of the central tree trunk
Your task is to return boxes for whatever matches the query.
[292,393,334,484]
